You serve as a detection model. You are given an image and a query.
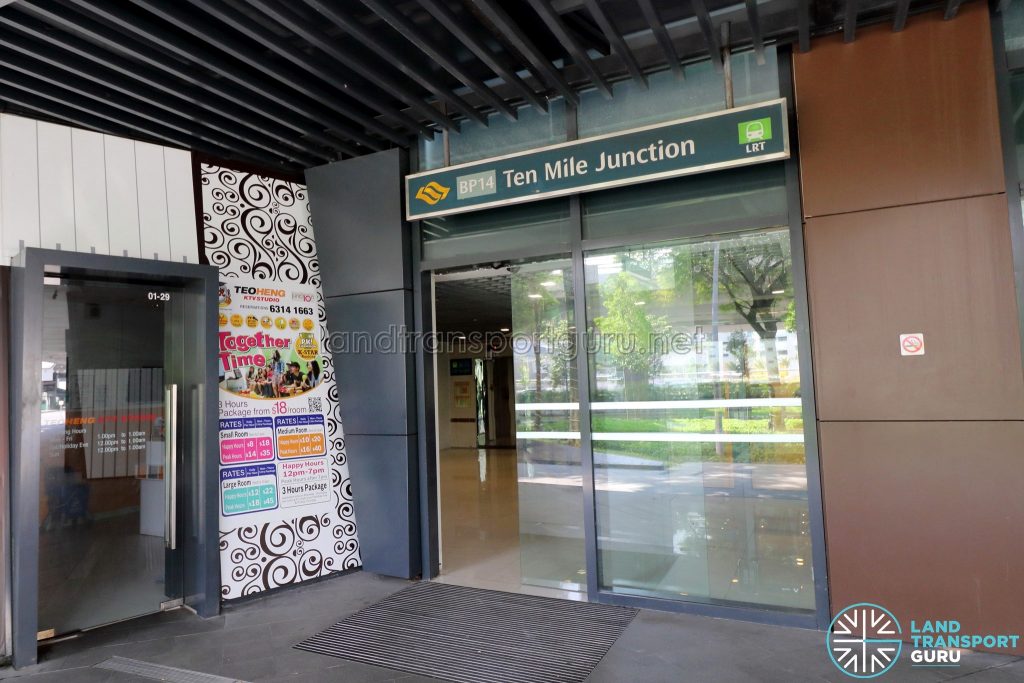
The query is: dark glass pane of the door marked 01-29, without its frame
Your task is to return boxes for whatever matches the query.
[39,278,184,635]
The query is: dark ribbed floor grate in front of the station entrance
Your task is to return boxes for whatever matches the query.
[296,583,637,683]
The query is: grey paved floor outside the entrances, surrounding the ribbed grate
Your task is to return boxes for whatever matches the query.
[0,571,1024,683]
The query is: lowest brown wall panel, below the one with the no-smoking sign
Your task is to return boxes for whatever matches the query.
[821,422,1024,654]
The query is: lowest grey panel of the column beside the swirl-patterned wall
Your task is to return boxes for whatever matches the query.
[343,436,420,579]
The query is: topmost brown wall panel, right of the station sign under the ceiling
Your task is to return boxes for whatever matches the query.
[794,2,1006,216]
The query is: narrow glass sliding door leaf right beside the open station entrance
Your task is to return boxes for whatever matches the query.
[511,259,587,592]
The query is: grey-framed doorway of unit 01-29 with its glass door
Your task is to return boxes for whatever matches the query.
[11,250,219,667]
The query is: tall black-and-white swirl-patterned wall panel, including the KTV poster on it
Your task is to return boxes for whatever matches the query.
[200,164,360,600]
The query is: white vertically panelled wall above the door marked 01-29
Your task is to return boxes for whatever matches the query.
[0,114,199,264]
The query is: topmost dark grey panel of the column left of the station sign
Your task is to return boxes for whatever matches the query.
[306,150,412,297]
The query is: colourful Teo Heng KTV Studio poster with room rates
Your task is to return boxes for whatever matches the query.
[217,279,331,529]
